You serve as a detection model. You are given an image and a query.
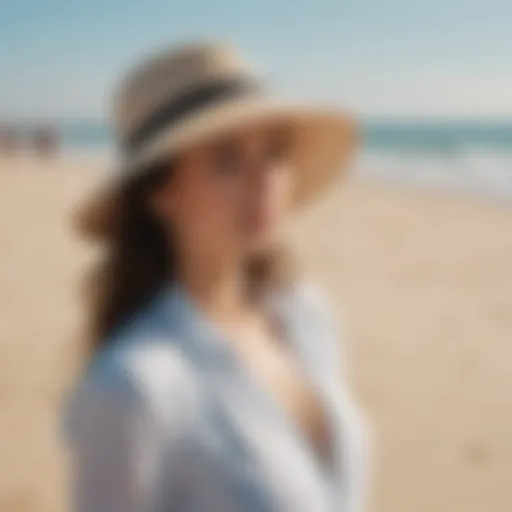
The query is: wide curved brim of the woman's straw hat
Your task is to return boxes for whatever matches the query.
[75,98,358,241]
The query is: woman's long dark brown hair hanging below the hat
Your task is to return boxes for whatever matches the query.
[88,162,292,352]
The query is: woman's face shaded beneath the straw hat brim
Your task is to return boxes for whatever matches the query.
[156,122,293,266]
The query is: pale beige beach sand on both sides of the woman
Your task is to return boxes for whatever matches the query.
[0,159,512,512]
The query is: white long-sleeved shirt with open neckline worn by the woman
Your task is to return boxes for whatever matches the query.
[65,285,367,512]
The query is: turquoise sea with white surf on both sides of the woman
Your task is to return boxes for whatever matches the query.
[61,120,512,200]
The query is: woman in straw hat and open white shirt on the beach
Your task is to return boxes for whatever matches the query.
[66,44,363,512]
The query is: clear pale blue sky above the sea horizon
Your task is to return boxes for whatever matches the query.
[0,0,512,119]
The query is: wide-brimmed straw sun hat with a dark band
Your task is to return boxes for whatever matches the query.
[75,44,356,240]
